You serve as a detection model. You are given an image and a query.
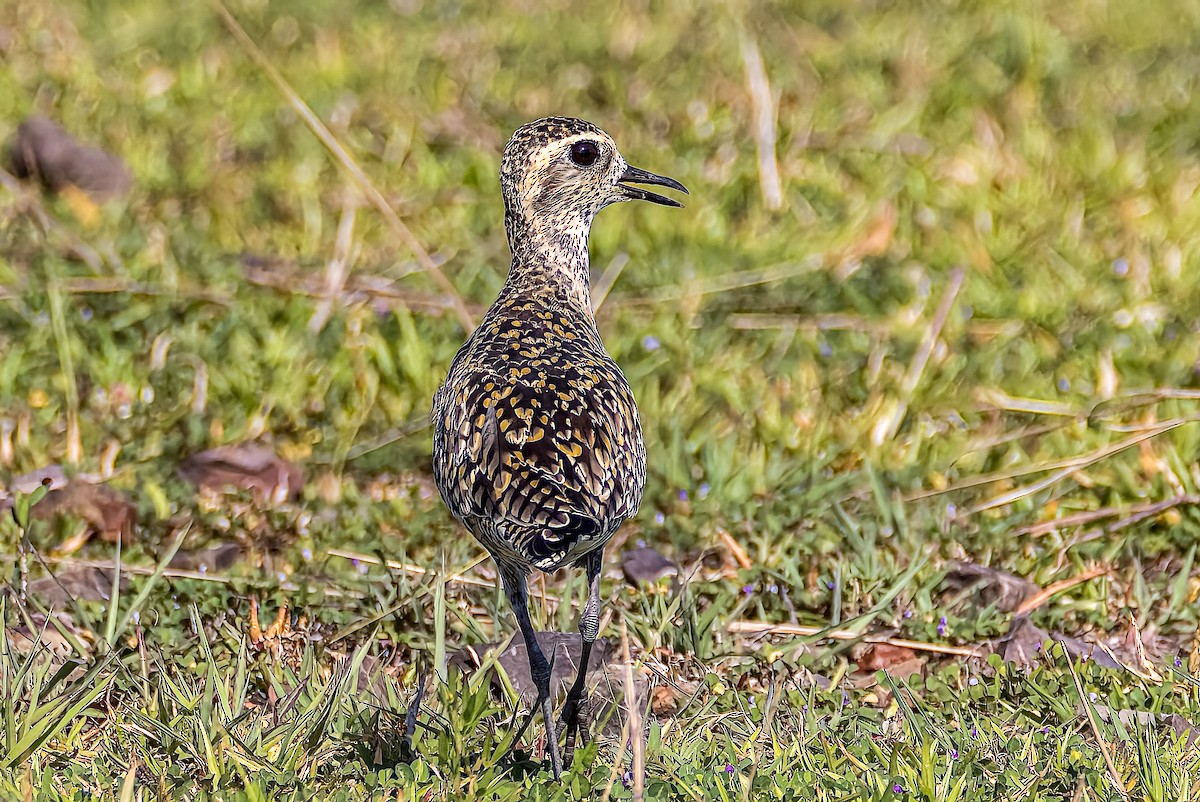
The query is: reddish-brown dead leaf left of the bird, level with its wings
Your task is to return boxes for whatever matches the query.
[179,443,304,503]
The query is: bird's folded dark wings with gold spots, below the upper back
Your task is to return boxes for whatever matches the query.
[438,367,644,564]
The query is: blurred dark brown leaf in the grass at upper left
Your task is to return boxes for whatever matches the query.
[8,116,133,201]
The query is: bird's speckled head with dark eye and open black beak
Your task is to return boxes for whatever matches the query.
[500,116,688,232]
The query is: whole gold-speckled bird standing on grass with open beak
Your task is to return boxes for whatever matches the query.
[431,116,688,778]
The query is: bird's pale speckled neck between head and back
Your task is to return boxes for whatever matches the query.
[504,213,592,316]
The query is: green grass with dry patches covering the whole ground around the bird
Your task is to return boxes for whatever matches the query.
[0,0,1200,801]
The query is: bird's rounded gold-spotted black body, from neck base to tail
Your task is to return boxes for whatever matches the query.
[433,300,646,570]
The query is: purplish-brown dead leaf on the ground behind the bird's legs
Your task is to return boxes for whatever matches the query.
[449,632,649,737]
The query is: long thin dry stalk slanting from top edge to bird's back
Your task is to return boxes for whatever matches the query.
[211,0,475,333]
